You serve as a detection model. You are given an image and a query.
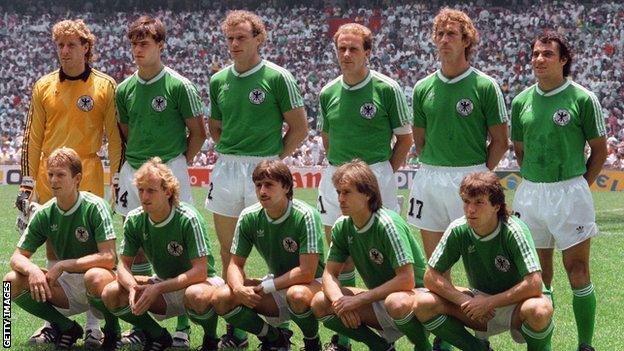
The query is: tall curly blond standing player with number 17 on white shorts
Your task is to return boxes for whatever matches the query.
[407,8,508,266]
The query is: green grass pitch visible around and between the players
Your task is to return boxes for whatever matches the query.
[0,186,624,351]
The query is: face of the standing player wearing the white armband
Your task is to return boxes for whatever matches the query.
[336,33,370,74]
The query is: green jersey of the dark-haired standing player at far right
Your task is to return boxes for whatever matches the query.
[511,80,606,183]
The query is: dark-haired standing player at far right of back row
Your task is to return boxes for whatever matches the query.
[511,31,607,351]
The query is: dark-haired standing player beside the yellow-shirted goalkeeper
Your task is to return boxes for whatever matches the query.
[115,16,206,347]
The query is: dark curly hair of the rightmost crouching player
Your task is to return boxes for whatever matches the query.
[459,172,509,222]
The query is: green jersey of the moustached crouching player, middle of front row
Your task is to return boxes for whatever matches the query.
[230,199,325,278]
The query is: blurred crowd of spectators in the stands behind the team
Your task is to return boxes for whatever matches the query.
[0,0,624,170]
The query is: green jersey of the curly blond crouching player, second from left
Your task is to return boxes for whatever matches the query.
[121,202,215,279]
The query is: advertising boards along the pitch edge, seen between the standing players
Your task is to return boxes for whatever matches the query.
[0,165,624,191]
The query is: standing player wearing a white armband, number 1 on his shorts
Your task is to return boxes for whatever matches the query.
[317,23,412,350]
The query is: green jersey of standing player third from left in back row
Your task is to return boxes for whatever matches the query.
[210,60,303,156]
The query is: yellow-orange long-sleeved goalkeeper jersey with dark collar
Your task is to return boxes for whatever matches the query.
[21,66,123,201]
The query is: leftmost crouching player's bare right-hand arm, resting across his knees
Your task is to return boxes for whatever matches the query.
[46,240,116,285]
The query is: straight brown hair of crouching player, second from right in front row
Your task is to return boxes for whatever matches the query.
[332,158,382,212]
